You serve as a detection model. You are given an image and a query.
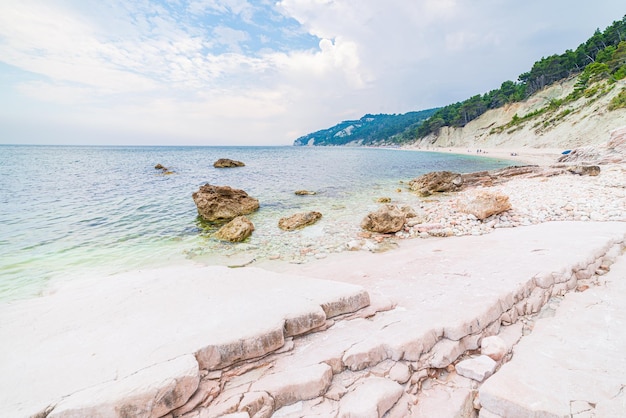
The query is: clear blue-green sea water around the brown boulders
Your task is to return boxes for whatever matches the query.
[0,146,510,300]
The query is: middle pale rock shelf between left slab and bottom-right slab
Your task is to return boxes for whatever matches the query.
[185,223,626,418]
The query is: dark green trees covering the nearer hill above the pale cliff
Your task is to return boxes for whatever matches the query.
[417,15,626,138]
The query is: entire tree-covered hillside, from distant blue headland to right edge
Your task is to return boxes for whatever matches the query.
[294,15,626,145]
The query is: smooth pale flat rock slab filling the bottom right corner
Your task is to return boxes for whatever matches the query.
[480,256,626,417]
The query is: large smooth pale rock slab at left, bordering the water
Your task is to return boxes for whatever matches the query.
[0,265,369,417]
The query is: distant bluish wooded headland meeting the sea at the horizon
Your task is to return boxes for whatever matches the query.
[294,109,436,145]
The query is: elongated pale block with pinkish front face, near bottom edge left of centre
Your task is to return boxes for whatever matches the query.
[250,363,333,409]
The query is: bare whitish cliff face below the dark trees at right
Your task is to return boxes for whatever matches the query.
[415,77,626,149]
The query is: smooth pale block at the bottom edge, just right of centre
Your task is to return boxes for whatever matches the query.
[337,377,404,418]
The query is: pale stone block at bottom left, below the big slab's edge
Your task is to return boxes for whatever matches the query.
[48,355,200,418]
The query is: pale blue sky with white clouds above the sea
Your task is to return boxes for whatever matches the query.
[0,0,626,145]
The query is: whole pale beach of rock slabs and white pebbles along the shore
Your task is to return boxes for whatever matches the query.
[0,141,626,418]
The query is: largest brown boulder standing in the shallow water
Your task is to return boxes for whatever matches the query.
[192,183,259,222]
